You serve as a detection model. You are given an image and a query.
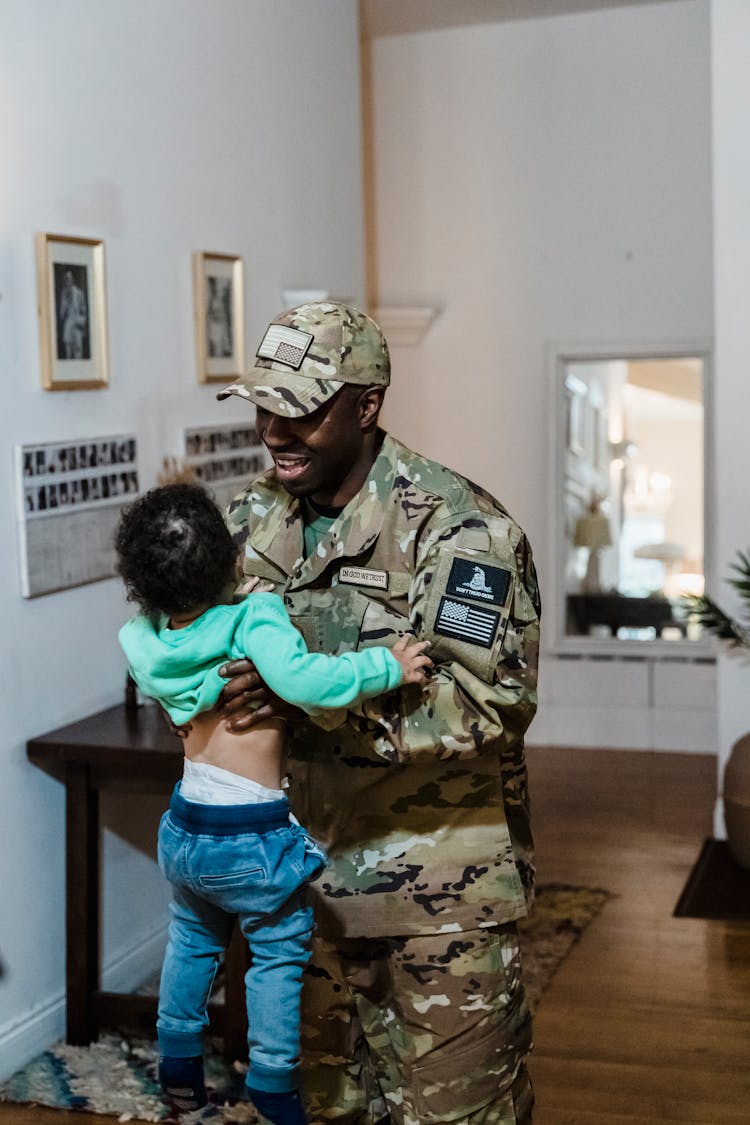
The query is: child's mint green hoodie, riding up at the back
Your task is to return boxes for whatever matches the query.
[119,594,403,726]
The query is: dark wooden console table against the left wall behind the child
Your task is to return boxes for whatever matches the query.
[27,704,247,1059]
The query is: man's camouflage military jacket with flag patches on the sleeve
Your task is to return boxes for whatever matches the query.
[227,435,540,937]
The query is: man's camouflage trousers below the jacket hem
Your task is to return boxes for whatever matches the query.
[302,924,533,1125]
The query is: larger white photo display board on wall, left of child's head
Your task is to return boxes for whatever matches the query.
[16,434,139,597]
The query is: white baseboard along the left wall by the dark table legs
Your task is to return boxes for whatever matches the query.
[0,925,166,1082]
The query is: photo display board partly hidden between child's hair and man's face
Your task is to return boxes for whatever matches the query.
[183,422,270,509]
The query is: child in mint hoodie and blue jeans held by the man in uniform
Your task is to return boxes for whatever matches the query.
[115,484,432,1125]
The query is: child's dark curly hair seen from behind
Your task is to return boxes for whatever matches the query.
[115,484,237,615]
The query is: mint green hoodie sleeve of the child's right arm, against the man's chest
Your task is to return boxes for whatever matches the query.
[239,594,403,714]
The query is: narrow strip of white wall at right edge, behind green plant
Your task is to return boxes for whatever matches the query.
[712,0,750,833]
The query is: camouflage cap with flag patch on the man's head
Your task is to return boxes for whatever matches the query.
[216,300,390,419]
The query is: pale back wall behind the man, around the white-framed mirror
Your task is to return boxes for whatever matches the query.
[370,0,715,752]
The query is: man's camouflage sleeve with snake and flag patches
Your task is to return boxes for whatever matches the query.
[352,512,541,764]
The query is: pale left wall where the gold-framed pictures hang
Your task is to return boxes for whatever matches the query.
[0,0,364,1078]
